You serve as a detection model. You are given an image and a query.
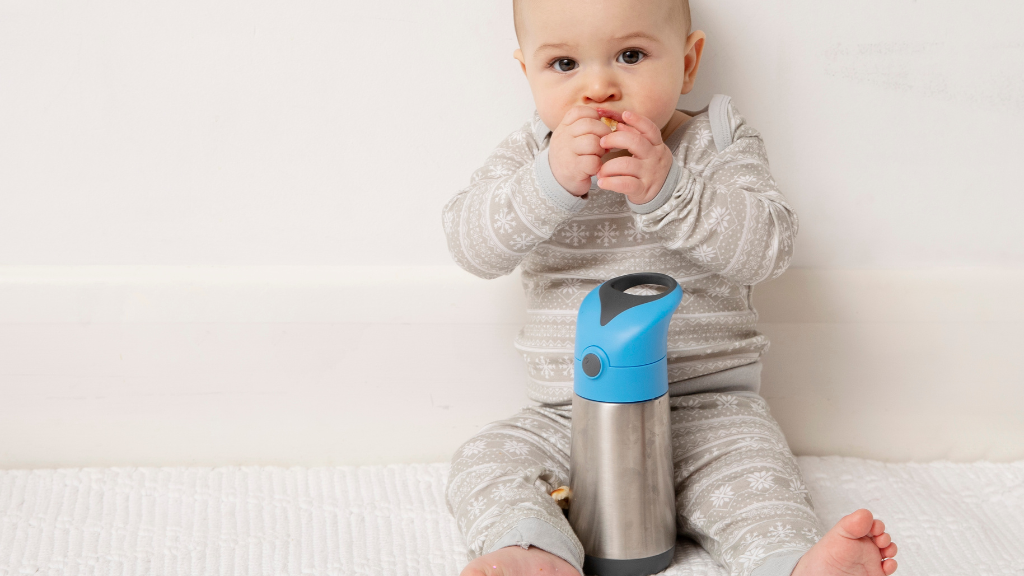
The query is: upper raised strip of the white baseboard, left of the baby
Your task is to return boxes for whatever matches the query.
[0,265,525,324]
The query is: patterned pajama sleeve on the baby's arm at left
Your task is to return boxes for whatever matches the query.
[442,115,587,279]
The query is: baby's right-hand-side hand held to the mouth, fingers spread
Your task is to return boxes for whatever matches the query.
[597,111,673,204]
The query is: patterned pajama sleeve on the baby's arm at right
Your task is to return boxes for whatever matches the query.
[630,96,799,285]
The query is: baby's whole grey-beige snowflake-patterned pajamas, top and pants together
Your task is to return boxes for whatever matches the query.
[442,96,820,576]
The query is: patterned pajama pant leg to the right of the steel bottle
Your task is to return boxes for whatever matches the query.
[670,393,821,576]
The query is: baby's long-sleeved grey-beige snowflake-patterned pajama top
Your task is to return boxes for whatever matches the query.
[442,95,798,404]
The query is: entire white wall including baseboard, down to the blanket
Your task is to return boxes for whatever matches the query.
[0,0,1024,466]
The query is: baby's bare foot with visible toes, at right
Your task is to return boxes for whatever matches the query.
[793,509,896,576]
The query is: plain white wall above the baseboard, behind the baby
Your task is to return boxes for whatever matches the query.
[6,0,1024,269]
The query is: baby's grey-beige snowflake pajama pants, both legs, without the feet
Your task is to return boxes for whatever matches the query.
[445,393,821,576]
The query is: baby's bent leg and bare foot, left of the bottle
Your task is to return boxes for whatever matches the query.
[445,406,583,574]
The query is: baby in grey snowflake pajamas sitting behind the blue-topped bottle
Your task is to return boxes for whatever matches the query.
[443,0,896,576]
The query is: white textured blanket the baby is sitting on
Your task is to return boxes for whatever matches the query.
[0,457,1024,576]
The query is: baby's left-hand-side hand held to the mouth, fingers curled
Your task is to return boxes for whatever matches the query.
[548,106,611,196]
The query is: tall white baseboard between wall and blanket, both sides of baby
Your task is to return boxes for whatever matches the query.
[0,266,1024,467]
